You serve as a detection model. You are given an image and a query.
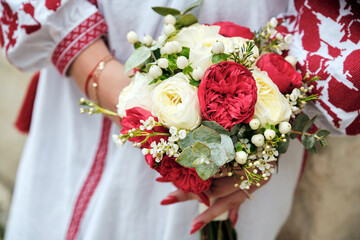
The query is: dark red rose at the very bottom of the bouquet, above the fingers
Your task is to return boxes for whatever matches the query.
[155,155,211,194]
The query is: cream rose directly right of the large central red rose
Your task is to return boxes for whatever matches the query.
[253,68,291,126]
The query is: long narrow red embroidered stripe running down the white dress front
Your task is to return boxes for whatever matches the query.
[66,118,111,240]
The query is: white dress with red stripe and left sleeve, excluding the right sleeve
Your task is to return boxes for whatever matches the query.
[0,0,358,240]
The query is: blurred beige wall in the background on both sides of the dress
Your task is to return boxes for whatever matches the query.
[0,54,360,240]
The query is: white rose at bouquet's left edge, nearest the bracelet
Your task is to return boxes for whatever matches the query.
[117,72,158,117]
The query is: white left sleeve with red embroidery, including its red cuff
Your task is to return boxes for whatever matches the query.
[0,0,107,75]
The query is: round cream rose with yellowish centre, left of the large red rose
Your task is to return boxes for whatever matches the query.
[152,73,201,129]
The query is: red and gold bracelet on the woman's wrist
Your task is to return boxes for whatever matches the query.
[85,55,115,104]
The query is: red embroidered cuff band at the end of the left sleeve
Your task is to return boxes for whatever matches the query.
[52,12,108,74]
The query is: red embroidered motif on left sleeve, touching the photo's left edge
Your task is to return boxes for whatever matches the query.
[0,0,18,52]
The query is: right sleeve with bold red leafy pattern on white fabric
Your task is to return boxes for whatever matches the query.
[285,0,360,135]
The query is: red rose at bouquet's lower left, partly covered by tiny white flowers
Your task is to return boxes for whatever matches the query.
[121,107,169,145]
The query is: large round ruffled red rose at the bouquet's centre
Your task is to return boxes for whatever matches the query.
[198,62,257,130]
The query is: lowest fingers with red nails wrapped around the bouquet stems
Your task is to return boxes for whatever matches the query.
[191,191,247,233]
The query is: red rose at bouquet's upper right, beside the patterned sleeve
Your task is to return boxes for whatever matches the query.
[256,53,302,94]
